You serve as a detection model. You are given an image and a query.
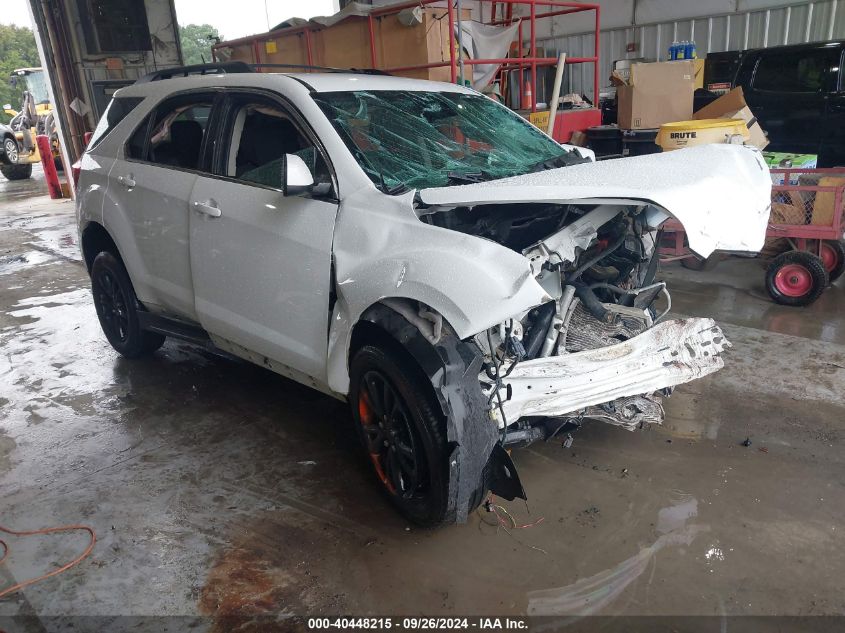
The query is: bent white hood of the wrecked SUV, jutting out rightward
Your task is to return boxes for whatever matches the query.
[420,145,772,257]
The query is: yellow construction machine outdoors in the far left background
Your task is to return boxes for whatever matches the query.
[0,68,61,180]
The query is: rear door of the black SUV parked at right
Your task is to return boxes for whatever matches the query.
[745,46,839,154]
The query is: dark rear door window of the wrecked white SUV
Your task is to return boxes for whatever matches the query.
[126,95,214,169]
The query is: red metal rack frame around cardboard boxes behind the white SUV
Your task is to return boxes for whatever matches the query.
[211,0,601,112]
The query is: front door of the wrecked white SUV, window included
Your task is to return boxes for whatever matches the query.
[190,93,338,383]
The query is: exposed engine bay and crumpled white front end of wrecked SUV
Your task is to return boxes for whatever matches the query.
[421,201,729,443]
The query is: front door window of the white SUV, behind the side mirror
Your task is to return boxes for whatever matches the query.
[225,102,331,189]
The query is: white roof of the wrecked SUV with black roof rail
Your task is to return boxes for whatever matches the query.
[116,72,477,97]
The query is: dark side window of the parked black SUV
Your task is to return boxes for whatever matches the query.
[753,50,830,92]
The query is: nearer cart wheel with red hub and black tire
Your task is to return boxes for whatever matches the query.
[766,251,828,306]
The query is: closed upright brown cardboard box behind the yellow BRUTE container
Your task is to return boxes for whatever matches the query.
[616,61,695,130]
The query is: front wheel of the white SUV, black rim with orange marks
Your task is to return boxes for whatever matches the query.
[349,344,449,527]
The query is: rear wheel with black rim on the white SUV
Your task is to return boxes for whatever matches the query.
[91,251,165,358]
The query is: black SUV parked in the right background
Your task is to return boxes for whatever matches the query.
[704,40,845,167]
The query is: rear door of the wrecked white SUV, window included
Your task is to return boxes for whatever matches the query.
[107,91,217,320]
